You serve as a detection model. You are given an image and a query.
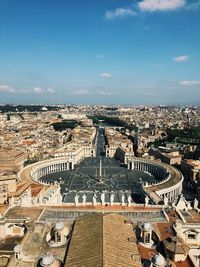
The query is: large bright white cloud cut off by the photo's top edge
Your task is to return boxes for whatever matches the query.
[138,0,186,12]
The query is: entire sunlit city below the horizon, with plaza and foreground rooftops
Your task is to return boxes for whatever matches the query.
[0,105,200,267]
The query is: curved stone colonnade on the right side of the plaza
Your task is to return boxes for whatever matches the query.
[128,158,183,202]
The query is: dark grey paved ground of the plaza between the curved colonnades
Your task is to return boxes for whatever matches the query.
[39,157,157,203]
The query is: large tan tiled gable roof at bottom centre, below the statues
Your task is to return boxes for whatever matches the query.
[65,214,142,267]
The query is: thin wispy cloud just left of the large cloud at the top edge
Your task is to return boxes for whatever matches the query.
[105,7,137,20]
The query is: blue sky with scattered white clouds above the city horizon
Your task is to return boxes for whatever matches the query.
[0,0,200,105]
